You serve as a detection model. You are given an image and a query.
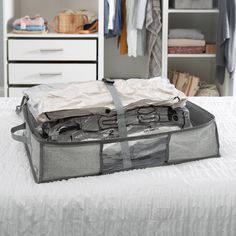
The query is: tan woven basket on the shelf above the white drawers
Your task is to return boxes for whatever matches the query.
[52,12,88,34]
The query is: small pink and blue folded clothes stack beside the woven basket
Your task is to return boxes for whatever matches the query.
[13,15,47,34]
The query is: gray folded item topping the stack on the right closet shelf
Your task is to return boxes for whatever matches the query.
[168,29,205,40]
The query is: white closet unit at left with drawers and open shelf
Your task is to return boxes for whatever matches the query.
[3,0,104,96]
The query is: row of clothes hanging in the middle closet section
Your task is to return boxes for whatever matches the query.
[105,0,161,63]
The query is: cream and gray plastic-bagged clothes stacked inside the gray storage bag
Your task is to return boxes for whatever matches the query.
[25,77,191,142]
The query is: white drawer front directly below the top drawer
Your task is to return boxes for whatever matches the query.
[8,63,97,85]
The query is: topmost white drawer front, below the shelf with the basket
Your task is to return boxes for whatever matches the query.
[8,39,97,61]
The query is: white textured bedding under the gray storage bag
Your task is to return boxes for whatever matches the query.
[0,97,236,236]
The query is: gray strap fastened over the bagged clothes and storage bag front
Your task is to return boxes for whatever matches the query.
[103,79,132,169]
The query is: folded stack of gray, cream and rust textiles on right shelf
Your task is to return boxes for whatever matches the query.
[168,29,206,54]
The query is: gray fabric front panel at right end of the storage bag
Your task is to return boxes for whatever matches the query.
[169,123,219,162]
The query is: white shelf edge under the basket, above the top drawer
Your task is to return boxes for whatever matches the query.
[7,32,98,39]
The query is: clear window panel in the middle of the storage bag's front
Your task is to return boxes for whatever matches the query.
[102,135,168,174]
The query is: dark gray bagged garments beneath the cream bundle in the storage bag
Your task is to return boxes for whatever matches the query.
[42,106,191,142]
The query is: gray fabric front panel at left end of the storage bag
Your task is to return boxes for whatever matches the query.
[43,144,100,181]
